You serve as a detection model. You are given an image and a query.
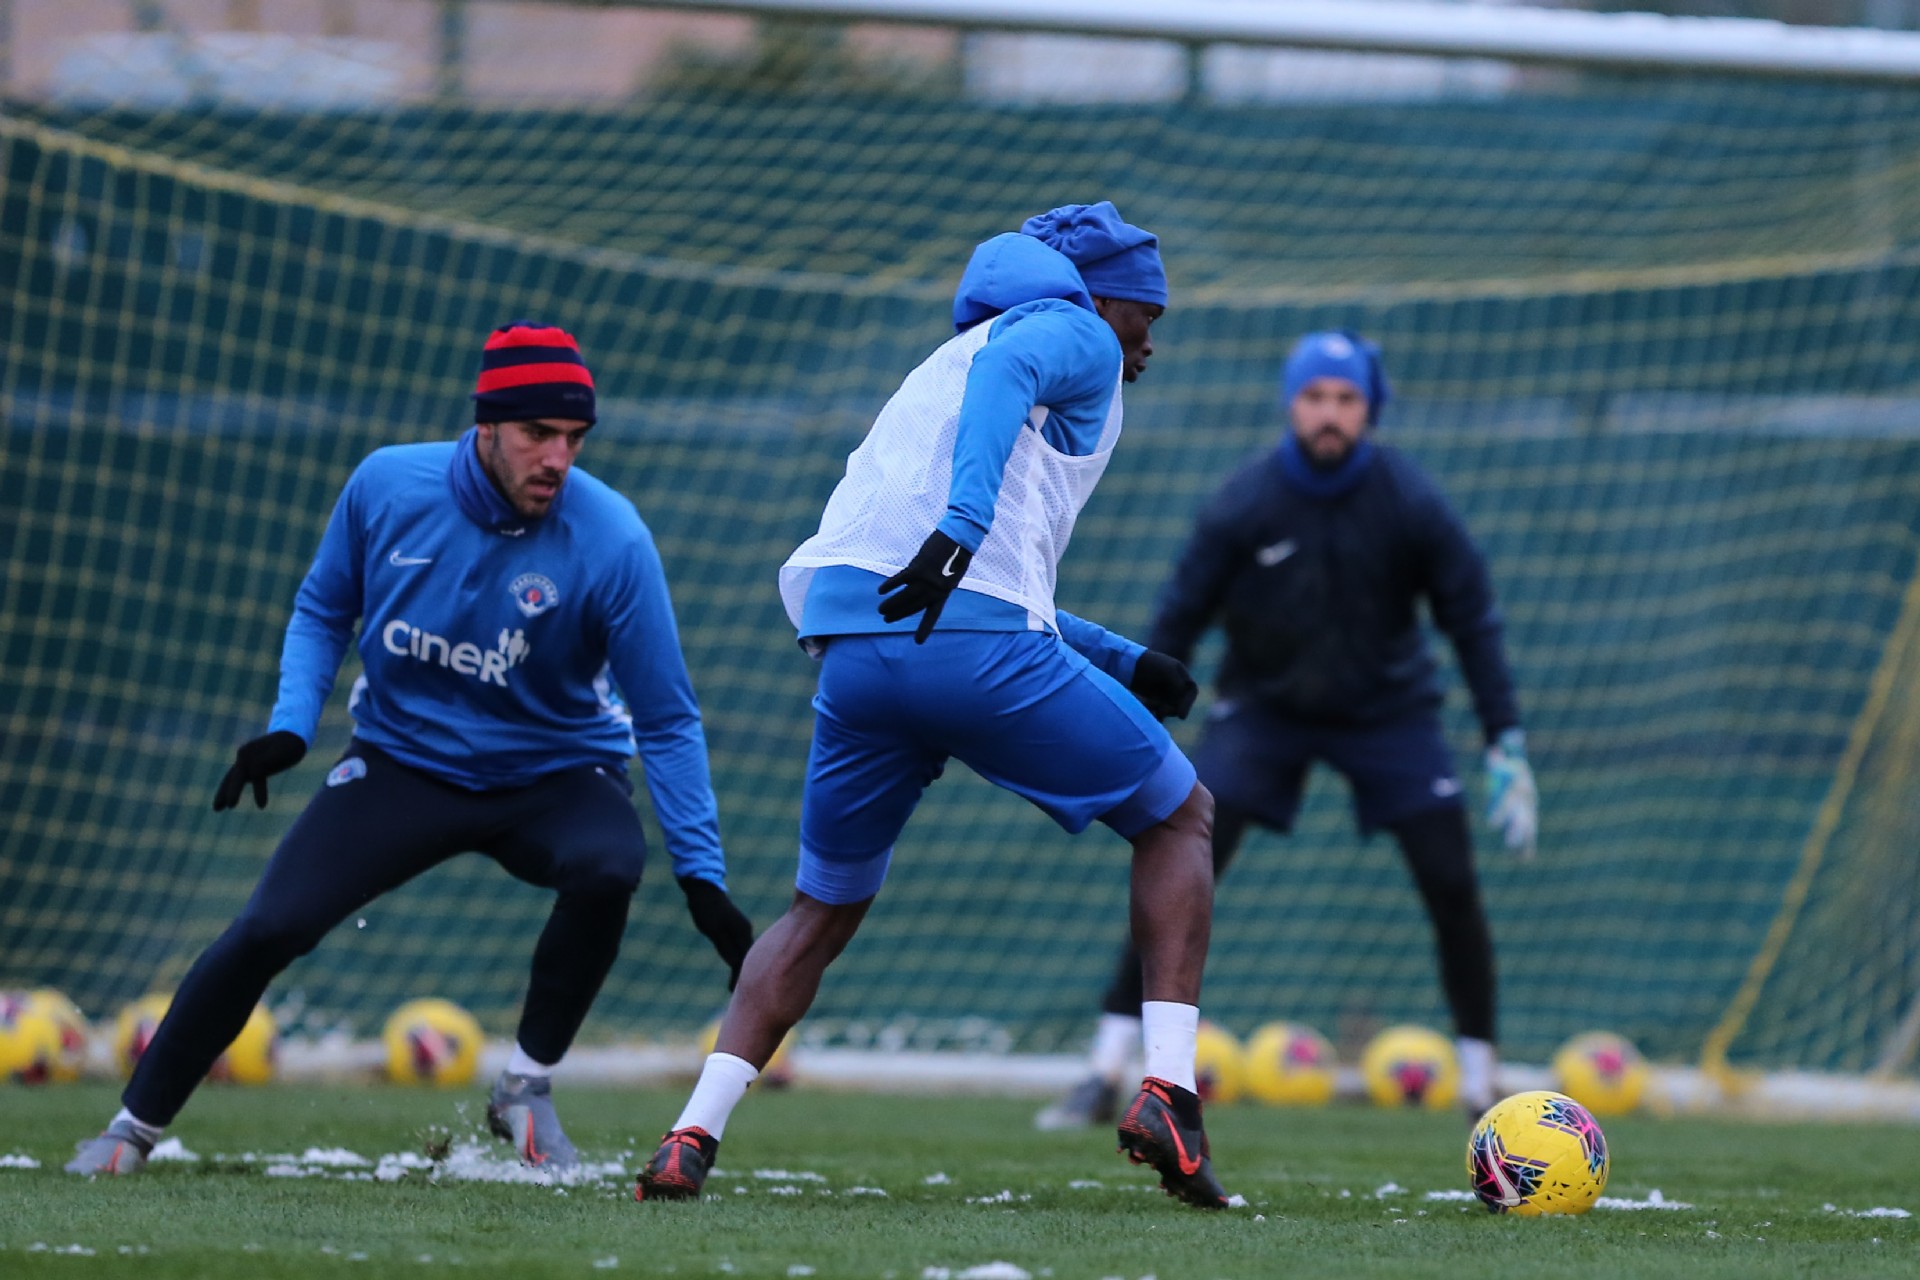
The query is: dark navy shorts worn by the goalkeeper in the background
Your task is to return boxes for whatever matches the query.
[1194,702,1463,831]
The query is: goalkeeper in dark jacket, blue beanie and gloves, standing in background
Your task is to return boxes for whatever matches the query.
[1035,332,1538,1128]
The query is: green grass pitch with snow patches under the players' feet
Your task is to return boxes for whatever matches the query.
[0,1084,1920,1280]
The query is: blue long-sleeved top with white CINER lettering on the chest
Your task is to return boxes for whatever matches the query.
[269,432,726,889]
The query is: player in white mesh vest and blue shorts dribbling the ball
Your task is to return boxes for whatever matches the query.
[636,201,1227,1207]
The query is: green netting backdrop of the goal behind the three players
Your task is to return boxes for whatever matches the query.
[0,27,1920,1069]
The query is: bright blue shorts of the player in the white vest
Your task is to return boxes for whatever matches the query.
[797,631,1194,904]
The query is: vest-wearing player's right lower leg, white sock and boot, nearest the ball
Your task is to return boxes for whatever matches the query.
[1119,783,1227,1209]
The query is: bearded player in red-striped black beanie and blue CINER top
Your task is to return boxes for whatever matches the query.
[67,322,753,1174]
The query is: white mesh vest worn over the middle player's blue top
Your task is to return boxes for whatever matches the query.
[780,322,1121,628]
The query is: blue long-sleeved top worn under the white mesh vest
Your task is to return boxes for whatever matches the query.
[801,297,1144,683]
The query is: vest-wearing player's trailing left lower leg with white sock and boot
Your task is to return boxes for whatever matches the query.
[634,892,874,1199]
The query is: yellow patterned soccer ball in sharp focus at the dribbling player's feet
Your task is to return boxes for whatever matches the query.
[1467,1088,1609,1219]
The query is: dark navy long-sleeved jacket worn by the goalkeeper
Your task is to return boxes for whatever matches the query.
[1148,441,1521,741]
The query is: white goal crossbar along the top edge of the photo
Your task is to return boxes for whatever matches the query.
[622,0,1920,83]
